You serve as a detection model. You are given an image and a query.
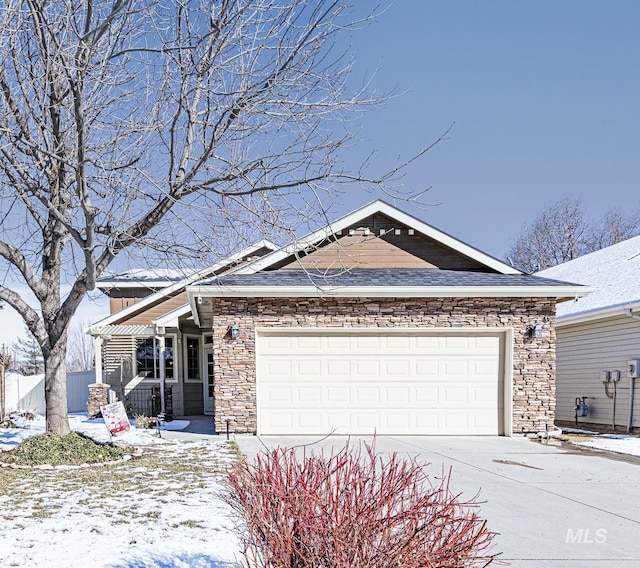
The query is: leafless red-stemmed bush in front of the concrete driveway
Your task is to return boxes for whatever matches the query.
[223,445,497,568]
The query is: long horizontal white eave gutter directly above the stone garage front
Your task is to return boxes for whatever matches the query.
[187,285,594,300]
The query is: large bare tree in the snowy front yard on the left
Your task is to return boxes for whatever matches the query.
[0,0,436,434]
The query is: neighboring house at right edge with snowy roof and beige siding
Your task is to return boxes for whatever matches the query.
[537,237,640,429]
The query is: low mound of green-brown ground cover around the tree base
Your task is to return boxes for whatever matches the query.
[0,432,128,466]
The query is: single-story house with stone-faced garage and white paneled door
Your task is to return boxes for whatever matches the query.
[93,201,590,435]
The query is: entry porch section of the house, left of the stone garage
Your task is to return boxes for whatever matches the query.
[89,241,276,416]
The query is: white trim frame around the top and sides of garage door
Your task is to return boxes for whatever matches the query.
[254,326,515,437]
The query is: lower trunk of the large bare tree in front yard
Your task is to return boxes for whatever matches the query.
[44,339,71,436]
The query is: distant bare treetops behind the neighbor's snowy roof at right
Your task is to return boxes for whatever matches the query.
[507,197,640,273]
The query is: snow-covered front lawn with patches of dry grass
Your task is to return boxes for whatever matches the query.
[0,415,240,568]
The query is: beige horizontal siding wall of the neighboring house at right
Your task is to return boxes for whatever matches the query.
[556,316,640,427]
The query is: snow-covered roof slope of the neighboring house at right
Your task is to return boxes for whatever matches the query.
[535,236,640,319]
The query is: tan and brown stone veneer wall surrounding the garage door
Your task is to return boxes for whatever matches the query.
[213,298,556,434]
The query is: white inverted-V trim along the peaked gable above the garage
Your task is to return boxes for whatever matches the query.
[234,200,522,274]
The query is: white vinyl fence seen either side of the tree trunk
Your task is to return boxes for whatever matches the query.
[5,371,96,414]
